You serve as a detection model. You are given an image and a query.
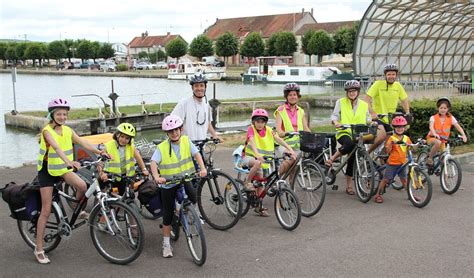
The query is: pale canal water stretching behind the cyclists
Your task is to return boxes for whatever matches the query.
[0,73,331,167]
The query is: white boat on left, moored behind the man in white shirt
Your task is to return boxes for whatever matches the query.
[168,62,225,80]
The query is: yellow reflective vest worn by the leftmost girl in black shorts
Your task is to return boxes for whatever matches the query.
[37,124,74,177]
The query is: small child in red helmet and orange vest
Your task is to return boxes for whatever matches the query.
[374,116,411,203]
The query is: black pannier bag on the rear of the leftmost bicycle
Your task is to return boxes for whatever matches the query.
[2,182,41,221]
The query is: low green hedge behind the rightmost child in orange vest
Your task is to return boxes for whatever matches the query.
[408,99,474,140]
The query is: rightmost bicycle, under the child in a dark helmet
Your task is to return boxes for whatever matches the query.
[416,135,464,195]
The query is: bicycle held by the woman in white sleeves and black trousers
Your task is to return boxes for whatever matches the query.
[326,124,376,203]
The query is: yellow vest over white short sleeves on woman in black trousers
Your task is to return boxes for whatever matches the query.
[336,97,369,139]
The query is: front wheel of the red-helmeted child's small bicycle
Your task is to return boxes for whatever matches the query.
[407,166,433,208]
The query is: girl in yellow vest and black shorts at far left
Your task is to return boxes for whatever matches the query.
[34,98,108,264]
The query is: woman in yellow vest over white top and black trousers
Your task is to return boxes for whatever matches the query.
[325,80,371,195]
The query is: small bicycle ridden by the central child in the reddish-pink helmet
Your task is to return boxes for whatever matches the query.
[234,154,301,231]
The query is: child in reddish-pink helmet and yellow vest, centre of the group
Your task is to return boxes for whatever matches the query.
[242,109,296,216]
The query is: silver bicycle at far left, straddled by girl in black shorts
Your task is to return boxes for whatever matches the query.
[17,157,144,264]
